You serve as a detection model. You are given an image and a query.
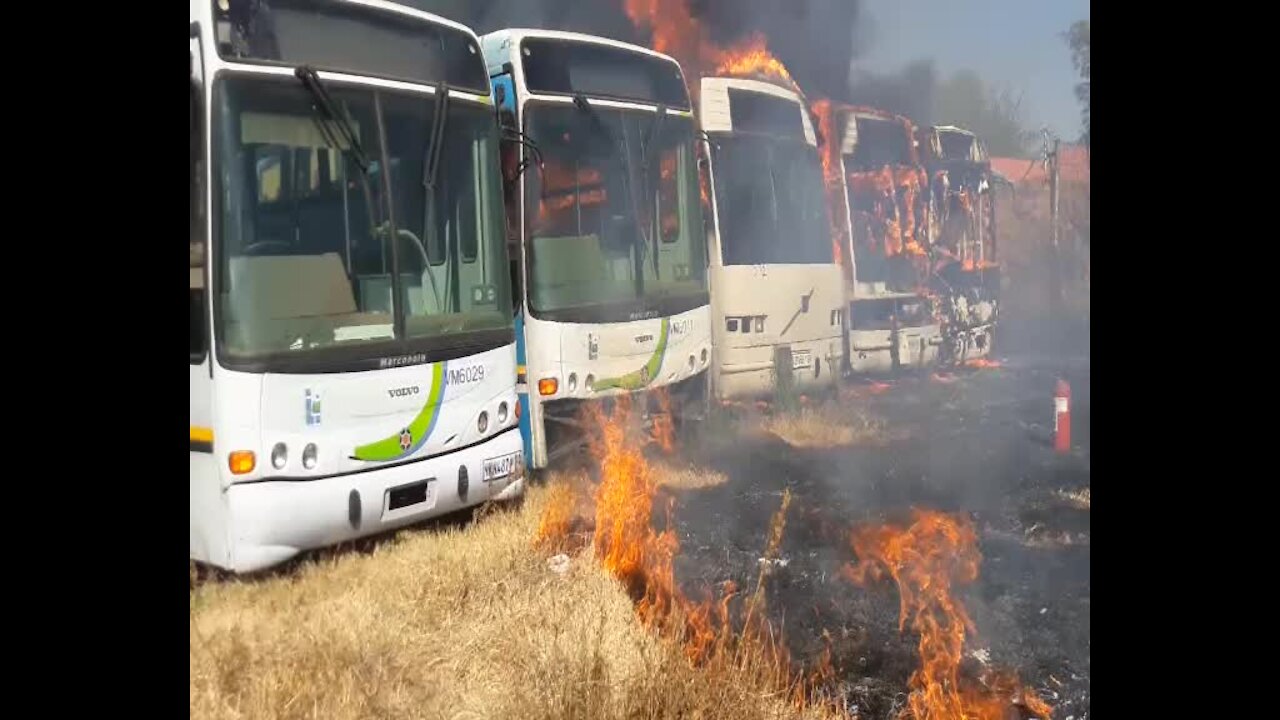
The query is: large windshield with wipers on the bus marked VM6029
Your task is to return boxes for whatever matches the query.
[214,76,512,359]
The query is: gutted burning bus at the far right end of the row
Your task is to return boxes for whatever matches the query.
[916,126,1000,363]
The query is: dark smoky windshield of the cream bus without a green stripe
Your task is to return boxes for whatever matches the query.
[712,133,835,265]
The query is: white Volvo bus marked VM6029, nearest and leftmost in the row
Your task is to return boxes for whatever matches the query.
[191,0,524,571]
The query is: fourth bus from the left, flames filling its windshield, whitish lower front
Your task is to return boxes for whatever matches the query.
[815,102,942,374]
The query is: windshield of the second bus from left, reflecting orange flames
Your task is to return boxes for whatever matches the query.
[525,102,707,315]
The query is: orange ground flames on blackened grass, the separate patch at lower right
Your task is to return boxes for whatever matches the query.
[845,510,1052,720]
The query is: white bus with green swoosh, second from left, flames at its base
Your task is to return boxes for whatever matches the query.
[481,29,712,468]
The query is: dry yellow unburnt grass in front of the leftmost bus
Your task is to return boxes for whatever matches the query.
[191,476,829,720]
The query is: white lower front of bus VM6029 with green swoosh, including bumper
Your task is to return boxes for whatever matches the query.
[191,345,524,571]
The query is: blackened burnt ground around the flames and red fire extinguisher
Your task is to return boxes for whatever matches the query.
[673,355,1089,720]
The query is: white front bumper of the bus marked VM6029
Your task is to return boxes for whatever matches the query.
[227,428,525,573]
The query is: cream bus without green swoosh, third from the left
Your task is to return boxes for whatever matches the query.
[699,77,845,400]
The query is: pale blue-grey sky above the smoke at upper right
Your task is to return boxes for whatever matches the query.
[856,0,1089,140]
